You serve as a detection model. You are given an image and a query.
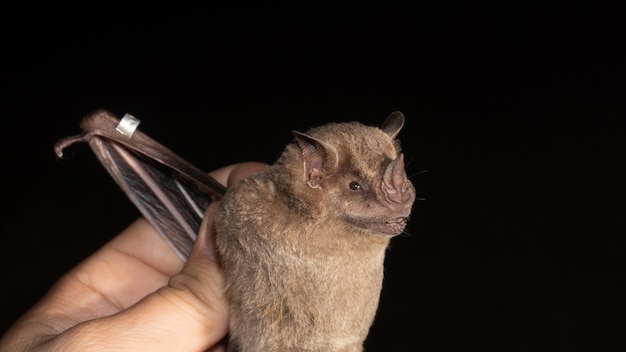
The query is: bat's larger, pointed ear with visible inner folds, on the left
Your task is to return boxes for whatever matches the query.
[291,131,339,188]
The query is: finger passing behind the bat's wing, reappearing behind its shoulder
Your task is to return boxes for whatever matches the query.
[24,162,266,326]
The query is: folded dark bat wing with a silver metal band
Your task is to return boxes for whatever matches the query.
[55,110,226,260]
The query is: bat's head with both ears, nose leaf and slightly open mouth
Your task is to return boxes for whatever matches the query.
[293,112,415,236]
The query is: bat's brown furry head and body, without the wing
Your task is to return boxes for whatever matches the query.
[216,113,415,352]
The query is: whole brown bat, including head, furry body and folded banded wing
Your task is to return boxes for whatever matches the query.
[57,111,415,352]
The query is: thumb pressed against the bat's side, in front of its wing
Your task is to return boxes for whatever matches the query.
[58,203,228,351]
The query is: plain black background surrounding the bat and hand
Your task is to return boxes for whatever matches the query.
[0,3,626,351]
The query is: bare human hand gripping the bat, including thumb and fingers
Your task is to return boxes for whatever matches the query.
[0,162,266,352]
